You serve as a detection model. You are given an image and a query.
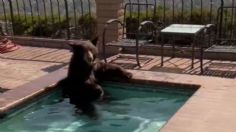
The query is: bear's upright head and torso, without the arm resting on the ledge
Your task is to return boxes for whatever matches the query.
[58,38,103,115]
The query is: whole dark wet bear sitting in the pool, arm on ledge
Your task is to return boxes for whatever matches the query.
[58,39,132,115]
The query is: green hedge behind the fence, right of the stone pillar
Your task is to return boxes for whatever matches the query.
[125,6,216,25]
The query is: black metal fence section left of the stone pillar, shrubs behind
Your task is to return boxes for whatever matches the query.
[0,0,96,39]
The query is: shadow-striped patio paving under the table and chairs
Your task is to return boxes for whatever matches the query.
[110,54,236,78]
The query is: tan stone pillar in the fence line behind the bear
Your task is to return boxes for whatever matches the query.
[96,0,123,51]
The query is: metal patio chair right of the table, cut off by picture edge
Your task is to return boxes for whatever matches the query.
[200,6,236,73]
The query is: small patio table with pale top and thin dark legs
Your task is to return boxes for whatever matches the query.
[160,24,205,68]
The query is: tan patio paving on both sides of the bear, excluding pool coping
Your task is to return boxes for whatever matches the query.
[0,46,236,89]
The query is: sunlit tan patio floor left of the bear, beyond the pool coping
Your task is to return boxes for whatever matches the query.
[0,46,71,89]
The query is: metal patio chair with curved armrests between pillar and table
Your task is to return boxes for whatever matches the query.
[102,3,159,66]
